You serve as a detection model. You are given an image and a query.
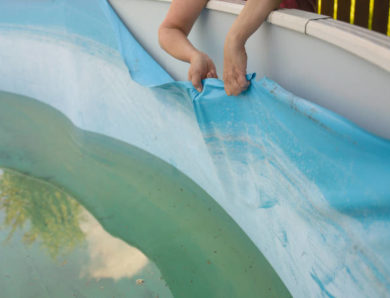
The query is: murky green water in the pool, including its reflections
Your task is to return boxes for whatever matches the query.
[0,92,289,297]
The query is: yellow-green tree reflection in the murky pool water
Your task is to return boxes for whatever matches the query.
[0,170,85,258]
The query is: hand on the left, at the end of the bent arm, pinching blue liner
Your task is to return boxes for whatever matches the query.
[188,52,218,92]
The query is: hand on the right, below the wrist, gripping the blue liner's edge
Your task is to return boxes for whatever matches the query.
[223,36,249,96]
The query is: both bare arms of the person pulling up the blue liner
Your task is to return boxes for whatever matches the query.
[159,0,281,95]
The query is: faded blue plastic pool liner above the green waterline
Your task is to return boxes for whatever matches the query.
[0,0,390,297]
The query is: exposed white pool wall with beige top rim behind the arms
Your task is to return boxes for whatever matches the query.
[110,0,390,139]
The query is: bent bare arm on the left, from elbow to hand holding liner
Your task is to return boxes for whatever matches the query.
[158,0,217,92]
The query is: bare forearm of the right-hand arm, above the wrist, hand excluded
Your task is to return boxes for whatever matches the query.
[227,0,282,44]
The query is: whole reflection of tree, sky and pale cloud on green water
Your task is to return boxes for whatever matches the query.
[0,169,172,297]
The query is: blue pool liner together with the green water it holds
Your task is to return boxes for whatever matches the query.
[0,0,390,297]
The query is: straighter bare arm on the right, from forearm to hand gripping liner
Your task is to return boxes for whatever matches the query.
[223,0,282,95]
